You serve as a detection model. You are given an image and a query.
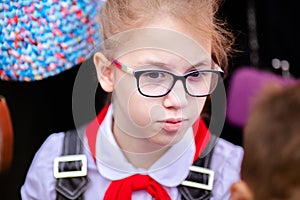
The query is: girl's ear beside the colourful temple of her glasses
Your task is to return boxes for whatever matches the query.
[94,52,114,92]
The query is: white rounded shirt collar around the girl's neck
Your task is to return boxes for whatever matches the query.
[96,106,195,187]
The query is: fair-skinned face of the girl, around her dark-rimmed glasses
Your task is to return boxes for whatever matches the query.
[100,19,211,152]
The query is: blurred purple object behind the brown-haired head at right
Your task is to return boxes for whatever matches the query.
[227,67,297,128]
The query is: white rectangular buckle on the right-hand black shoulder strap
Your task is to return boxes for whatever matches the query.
[181,166,215,190]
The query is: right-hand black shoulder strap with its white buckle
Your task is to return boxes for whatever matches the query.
[178,149,214,200]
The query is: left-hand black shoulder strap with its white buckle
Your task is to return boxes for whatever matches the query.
[54,130,88,200]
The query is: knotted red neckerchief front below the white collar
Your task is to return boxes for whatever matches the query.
[104,174,171,200]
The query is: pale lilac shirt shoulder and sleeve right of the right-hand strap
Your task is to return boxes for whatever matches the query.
[211,138,244,200]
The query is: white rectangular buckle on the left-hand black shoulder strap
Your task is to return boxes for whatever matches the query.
[53,154,87,178]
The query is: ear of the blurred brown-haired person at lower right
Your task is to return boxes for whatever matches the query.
[230,181,254,200]
